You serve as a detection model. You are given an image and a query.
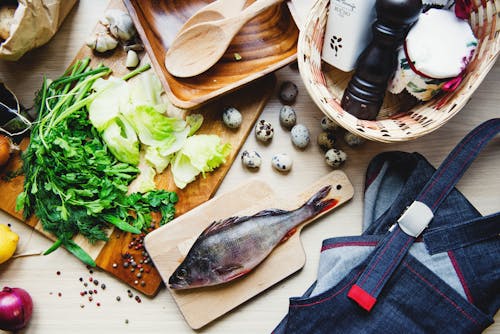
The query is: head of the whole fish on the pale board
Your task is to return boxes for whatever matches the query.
[168,257,219,290]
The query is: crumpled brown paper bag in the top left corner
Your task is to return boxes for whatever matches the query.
[0,0,77,60]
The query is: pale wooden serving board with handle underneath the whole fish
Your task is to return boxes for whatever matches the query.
[145,171,354,329]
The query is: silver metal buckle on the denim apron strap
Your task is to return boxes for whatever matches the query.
[398,201,434,238]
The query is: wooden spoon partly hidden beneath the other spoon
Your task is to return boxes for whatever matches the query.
[178,0,247,35]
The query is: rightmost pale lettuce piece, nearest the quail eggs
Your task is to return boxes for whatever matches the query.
[171,135,231,189]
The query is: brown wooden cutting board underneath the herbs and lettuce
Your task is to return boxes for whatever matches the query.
[0,0,276,296]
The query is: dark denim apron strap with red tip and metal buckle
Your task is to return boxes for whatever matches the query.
[347,118,500,311]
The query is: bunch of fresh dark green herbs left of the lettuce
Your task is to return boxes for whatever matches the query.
[17,59,177,265]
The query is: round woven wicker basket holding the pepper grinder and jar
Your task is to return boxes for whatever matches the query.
[298,0,500,142]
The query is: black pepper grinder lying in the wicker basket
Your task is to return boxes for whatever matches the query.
[341,0,422,120]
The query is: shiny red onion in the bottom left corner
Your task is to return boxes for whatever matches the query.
[0,287,33,331]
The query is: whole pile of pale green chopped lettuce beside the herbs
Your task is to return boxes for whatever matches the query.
[89,72,231,192]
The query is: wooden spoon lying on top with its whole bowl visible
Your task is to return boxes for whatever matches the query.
[165,0,283,78]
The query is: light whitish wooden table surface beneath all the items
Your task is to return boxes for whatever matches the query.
[0,0,500,333]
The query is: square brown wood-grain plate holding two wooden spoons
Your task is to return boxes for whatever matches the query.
[124,0,299,109]
